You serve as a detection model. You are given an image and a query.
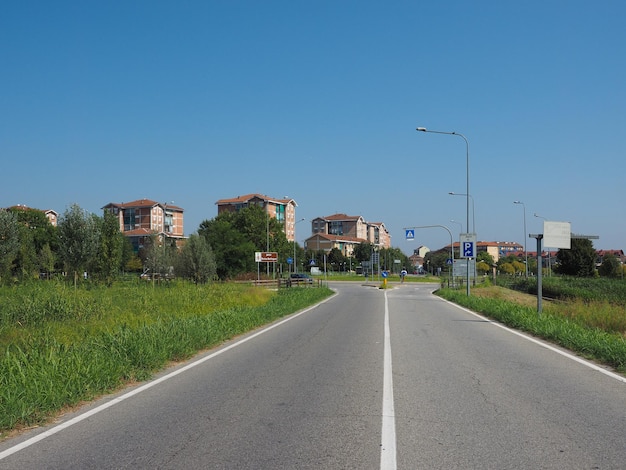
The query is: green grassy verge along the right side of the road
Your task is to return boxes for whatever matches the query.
[437,287,626,373]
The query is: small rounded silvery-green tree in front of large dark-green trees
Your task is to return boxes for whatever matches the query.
[175,234,217,284]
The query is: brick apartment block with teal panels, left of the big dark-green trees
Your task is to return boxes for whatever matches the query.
[102,199,185,251]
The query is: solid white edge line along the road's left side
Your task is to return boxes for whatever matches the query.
[0,296,334,460]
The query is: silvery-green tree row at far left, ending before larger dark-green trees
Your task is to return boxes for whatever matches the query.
[0,204,216,285]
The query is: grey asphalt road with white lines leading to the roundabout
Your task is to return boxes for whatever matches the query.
[0,283,626,470]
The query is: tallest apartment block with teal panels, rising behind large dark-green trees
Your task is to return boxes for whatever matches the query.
[215,193,298,242]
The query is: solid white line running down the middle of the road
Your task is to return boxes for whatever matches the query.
[380,291,397,470]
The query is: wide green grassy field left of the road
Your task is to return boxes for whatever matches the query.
[0,283,332,432]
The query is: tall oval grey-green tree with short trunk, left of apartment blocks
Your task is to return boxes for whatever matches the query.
[58,204,99,286]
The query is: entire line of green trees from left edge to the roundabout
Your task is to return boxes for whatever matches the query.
[0,204,409,284]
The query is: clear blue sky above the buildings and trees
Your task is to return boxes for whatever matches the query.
[0,0,626,253]
